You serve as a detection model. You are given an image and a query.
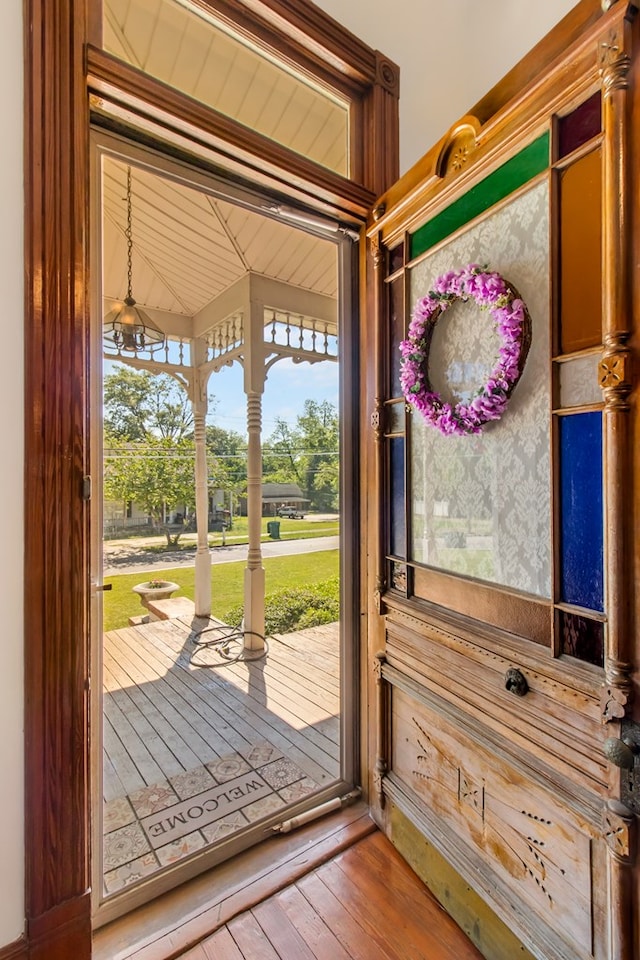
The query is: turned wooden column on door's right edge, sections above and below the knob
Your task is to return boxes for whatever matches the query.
[599,11,636,960]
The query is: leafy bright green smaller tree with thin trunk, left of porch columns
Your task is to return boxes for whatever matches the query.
[104,437,195,546]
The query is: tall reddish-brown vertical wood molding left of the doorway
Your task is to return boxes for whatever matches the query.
[25,0,91,960]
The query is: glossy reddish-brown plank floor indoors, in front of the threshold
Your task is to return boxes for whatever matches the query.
[172,832,481,960]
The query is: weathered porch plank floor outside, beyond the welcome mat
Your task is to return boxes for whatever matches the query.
[103,620,340,801]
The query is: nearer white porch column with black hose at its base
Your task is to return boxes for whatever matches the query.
[244,297,265,650]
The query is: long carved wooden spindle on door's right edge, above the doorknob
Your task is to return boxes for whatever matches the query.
[598,15,633,723]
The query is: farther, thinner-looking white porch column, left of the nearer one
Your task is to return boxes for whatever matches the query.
[191,340,211,617]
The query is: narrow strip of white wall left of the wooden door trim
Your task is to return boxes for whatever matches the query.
[0,0,24,945]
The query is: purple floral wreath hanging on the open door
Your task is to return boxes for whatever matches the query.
[400,263,531,436]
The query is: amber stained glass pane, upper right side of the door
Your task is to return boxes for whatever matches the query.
[560,150,602,353]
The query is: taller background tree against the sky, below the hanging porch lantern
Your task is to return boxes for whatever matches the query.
[104,367,193,441]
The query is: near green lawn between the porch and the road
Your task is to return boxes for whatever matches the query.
[103,548,339,631]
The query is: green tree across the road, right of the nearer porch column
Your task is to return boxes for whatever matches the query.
[263,400,340,510]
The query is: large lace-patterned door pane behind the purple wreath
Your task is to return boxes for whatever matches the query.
[409,181,551,597]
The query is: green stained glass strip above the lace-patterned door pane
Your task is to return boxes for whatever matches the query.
[411,132,549,259]
